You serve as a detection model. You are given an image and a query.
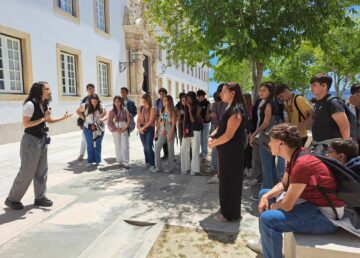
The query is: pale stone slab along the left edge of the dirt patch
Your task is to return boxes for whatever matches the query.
[79,219,164,258]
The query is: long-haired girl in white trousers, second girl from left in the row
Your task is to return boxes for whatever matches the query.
[108,96,131,169]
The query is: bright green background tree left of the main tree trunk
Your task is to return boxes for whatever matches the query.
[211,58,252,93]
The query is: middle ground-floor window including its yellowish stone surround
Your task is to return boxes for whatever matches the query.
[56,44,82,101]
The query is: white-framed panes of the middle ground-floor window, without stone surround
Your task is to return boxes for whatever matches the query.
[60,52,77,96]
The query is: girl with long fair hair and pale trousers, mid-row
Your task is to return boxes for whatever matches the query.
[151,95,176,173]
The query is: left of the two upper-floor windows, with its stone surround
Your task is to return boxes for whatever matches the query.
[54,0,80,24]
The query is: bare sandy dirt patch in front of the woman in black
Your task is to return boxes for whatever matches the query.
[148,226,262,258]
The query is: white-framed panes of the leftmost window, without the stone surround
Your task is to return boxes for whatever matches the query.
[0,34,24,93]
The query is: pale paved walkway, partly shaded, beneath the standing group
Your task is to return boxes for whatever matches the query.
[0,132,258,258]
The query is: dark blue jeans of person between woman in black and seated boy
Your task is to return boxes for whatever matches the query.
[259,146,279,189]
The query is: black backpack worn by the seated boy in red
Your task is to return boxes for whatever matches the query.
[289,151,360,220]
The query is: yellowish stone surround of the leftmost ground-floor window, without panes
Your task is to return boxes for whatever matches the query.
[0,25,33,101]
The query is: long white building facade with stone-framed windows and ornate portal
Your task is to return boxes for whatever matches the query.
[0,0,208,144]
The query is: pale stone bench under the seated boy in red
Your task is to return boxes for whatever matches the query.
[284,229,360,258]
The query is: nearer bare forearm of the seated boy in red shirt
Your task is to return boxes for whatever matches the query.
[271,184,306,211]
